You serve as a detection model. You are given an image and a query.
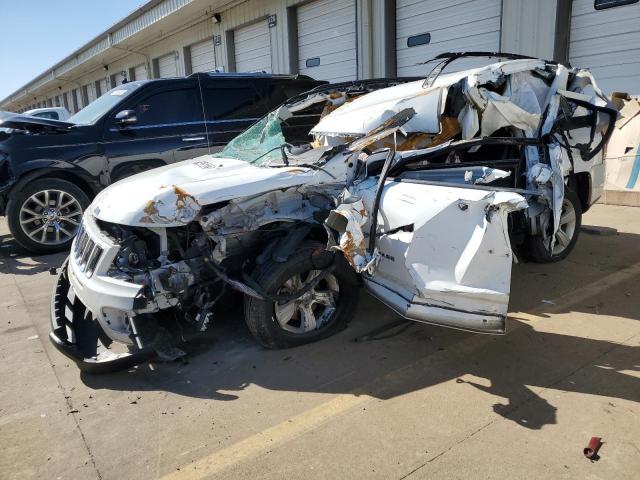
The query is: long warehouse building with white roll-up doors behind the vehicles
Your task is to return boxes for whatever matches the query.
[0,0,640,112]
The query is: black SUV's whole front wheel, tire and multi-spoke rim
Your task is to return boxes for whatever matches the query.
[7,179,89,253]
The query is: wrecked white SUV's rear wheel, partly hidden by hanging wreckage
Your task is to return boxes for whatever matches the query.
[525,189,582,263]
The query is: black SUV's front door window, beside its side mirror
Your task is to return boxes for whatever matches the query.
[131,88,202,126]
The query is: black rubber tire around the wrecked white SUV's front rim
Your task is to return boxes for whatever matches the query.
[244,241,359,349]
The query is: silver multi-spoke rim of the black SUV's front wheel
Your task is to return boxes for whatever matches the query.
[20,190,82,245]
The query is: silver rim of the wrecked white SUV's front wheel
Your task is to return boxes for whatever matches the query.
[274,270,340,334]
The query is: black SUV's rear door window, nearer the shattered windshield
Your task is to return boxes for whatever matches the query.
[203,81,267,120]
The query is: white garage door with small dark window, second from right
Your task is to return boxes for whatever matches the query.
[396,0,502,76]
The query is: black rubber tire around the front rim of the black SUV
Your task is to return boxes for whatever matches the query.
[7,178,90,254]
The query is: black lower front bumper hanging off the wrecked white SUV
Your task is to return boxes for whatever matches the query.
[49,259,155,373]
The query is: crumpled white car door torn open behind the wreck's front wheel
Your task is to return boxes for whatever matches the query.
[360,179,527,333]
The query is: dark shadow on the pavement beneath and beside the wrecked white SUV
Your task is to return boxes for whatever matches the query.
[76,225,640,429]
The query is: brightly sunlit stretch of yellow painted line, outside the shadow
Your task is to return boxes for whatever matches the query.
[162,394,371,480]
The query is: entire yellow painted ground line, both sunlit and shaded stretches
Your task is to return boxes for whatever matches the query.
[162,262,640,480]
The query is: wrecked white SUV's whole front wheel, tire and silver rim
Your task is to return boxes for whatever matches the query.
[244,242,358,348]
